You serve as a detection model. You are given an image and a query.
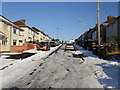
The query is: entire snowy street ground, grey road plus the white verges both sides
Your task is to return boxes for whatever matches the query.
[0,45,119,88]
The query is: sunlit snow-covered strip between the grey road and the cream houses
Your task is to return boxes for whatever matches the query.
[0,46,60,89]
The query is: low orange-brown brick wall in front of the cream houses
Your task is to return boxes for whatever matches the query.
[11,42,36,53]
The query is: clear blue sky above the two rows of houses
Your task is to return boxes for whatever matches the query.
[2,2,118,40]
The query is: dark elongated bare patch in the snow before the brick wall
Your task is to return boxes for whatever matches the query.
[6,53,35,59]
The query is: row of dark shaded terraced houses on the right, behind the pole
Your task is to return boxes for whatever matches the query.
[77,16,120,54]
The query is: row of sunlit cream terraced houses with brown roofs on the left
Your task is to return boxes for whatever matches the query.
[0,16,51,52]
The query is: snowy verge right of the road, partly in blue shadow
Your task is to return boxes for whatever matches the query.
[76,46,120,88]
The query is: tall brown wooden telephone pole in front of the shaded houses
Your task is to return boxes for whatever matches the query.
[97,0,100,54]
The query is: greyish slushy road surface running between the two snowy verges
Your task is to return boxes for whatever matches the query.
[7,46,102,88]
